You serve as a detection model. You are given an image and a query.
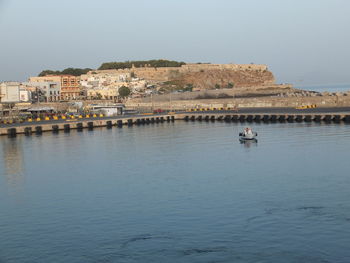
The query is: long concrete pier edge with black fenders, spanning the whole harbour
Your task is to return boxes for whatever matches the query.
[0,111,350,136]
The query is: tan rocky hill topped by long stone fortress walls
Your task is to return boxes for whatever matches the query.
[85,64,275,89]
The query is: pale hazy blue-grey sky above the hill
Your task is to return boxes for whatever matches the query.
[0,0,350,86]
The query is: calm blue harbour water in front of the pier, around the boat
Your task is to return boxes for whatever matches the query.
[0,122,350,263]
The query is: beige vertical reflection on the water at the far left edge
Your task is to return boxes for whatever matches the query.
[1,138,24,189]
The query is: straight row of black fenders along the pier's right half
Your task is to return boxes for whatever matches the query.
[184,114,350,123]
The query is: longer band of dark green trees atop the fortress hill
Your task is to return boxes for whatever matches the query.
[98,59,186,70]
